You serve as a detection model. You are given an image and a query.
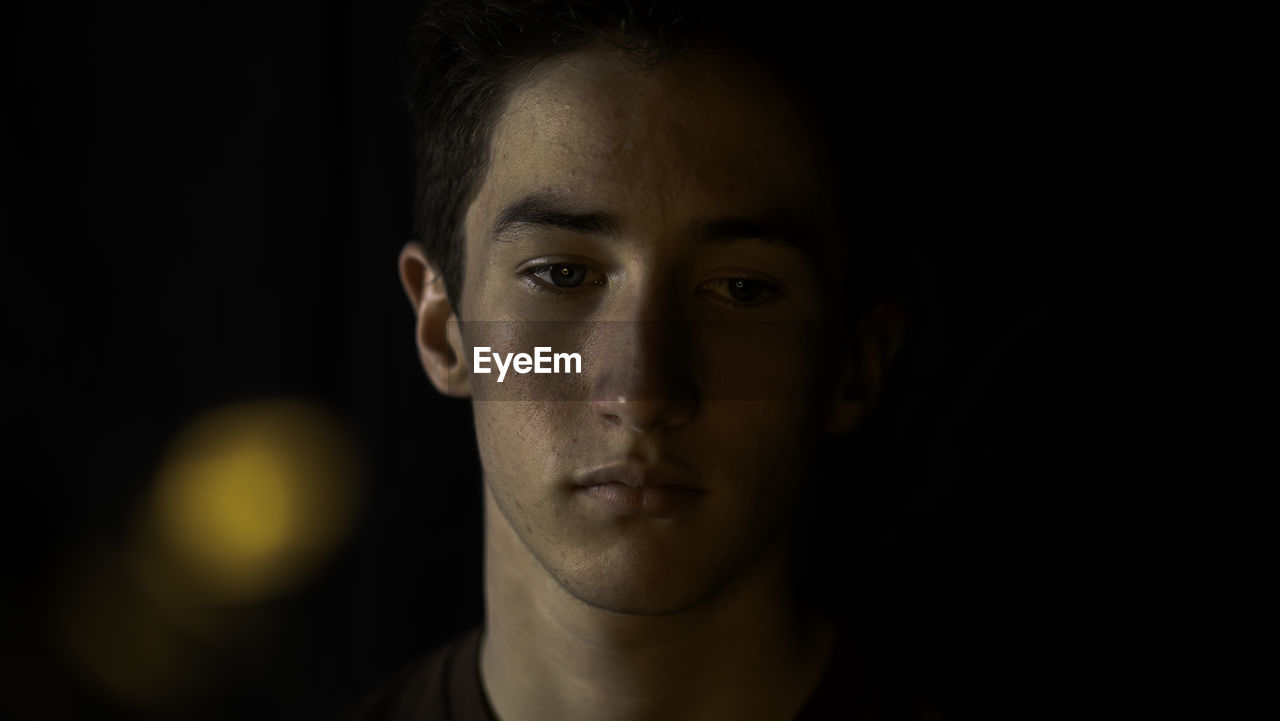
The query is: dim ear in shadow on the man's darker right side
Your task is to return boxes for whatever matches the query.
[826,300,906,434]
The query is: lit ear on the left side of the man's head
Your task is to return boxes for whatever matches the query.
[399,241,471,398]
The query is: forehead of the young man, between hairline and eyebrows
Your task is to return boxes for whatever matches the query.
[468,47,838,248]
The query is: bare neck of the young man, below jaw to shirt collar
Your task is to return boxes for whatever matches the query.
[480,484,835,721]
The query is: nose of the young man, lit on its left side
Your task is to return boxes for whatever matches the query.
[591,320,699,433]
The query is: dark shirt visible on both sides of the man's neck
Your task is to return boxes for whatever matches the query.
[347,629,932,721]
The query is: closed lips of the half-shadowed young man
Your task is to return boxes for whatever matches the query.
[573,464,705,519]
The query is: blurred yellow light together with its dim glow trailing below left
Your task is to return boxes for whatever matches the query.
[52,400,358,713]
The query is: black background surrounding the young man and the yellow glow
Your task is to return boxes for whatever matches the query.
[0,1,1259,718]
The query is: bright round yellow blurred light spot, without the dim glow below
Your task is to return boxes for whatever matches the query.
[150,400,357,603]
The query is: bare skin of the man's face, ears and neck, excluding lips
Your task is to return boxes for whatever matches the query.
[401,47,901,721]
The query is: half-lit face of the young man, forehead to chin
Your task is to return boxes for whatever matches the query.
[460,43,846,613]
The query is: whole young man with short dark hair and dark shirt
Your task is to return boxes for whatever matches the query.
[362,3,916,721]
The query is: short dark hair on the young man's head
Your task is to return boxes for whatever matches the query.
[408,0,899,316]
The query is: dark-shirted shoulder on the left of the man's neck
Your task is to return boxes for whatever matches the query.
[340,629,493,721]
